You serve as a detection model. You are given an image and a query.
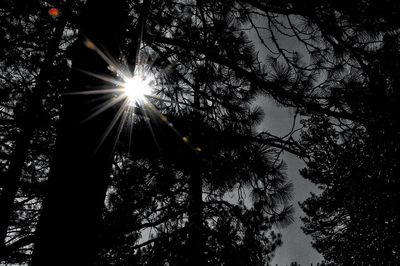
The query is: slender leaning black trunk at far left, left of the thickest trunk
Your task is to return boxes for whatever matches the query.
[0,14,65,257]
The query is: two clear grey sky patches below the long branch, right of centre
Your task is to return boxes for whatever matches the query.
[254,97,322,266]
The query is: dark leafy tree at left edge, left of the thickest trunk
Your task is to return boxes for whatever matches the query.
[0,2,72,257]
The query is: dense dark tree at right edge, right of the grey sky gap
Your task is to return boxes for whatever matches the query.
[302,37,399,265]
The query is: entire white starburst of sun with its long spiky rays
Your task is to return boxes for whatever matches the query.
[70,36,204,156]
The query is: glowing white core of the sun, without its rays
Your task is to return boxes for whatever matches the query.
[122,75,152,106]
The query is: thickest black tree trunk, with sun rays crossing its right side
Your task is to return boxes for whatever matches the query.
[32,0,128,266]
